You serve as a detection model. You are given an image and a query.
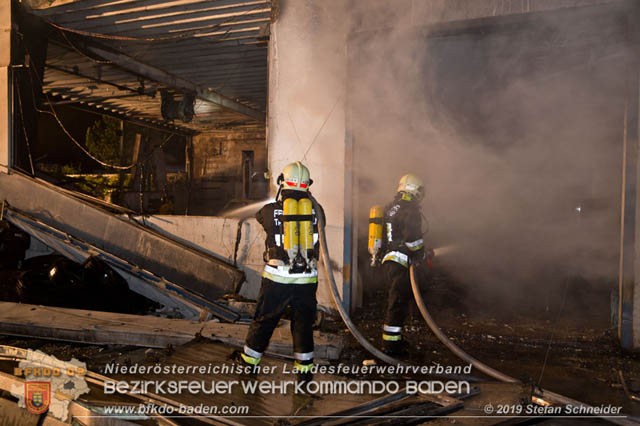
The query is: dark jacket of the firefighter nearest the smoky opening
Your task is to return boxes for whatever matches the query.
[382,196,424,267]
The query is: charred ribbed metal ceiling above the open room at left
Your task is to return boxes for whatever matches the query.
[23,0,273,132]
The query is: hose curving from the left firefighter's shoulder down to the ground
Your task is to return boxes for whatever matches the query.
[309,194,407,366]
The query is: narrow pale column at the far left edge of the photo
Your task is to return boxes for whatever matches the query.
[0,0,13,173]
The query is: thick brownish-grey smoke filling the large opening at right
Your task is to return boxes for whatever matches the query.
[348,2,625,308]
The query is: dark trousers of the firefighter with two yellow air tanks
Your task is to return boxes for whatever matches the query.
[244,278,318,371]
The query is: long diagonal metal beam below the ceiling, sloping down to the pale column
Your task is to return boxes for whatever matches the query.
[87,46,265,121]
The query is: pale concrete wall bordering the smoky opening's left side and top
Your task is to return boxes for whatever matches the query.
[267,0,609,310]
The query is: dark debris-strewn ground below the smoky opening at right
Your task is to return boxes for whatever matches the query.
[342,266,640,416]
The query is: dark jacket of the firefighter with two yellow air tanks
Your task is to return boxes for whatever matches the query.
[256,192,325,284]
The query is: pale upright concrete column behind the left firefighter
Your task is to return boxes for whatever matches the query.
[267,0,350,306]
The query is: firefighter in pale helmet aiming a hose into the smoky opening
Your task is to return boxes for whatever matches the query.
[382,174,433,355]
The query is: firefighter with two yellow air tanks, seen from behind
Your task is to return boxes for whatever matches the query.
[237,161,324,380]
